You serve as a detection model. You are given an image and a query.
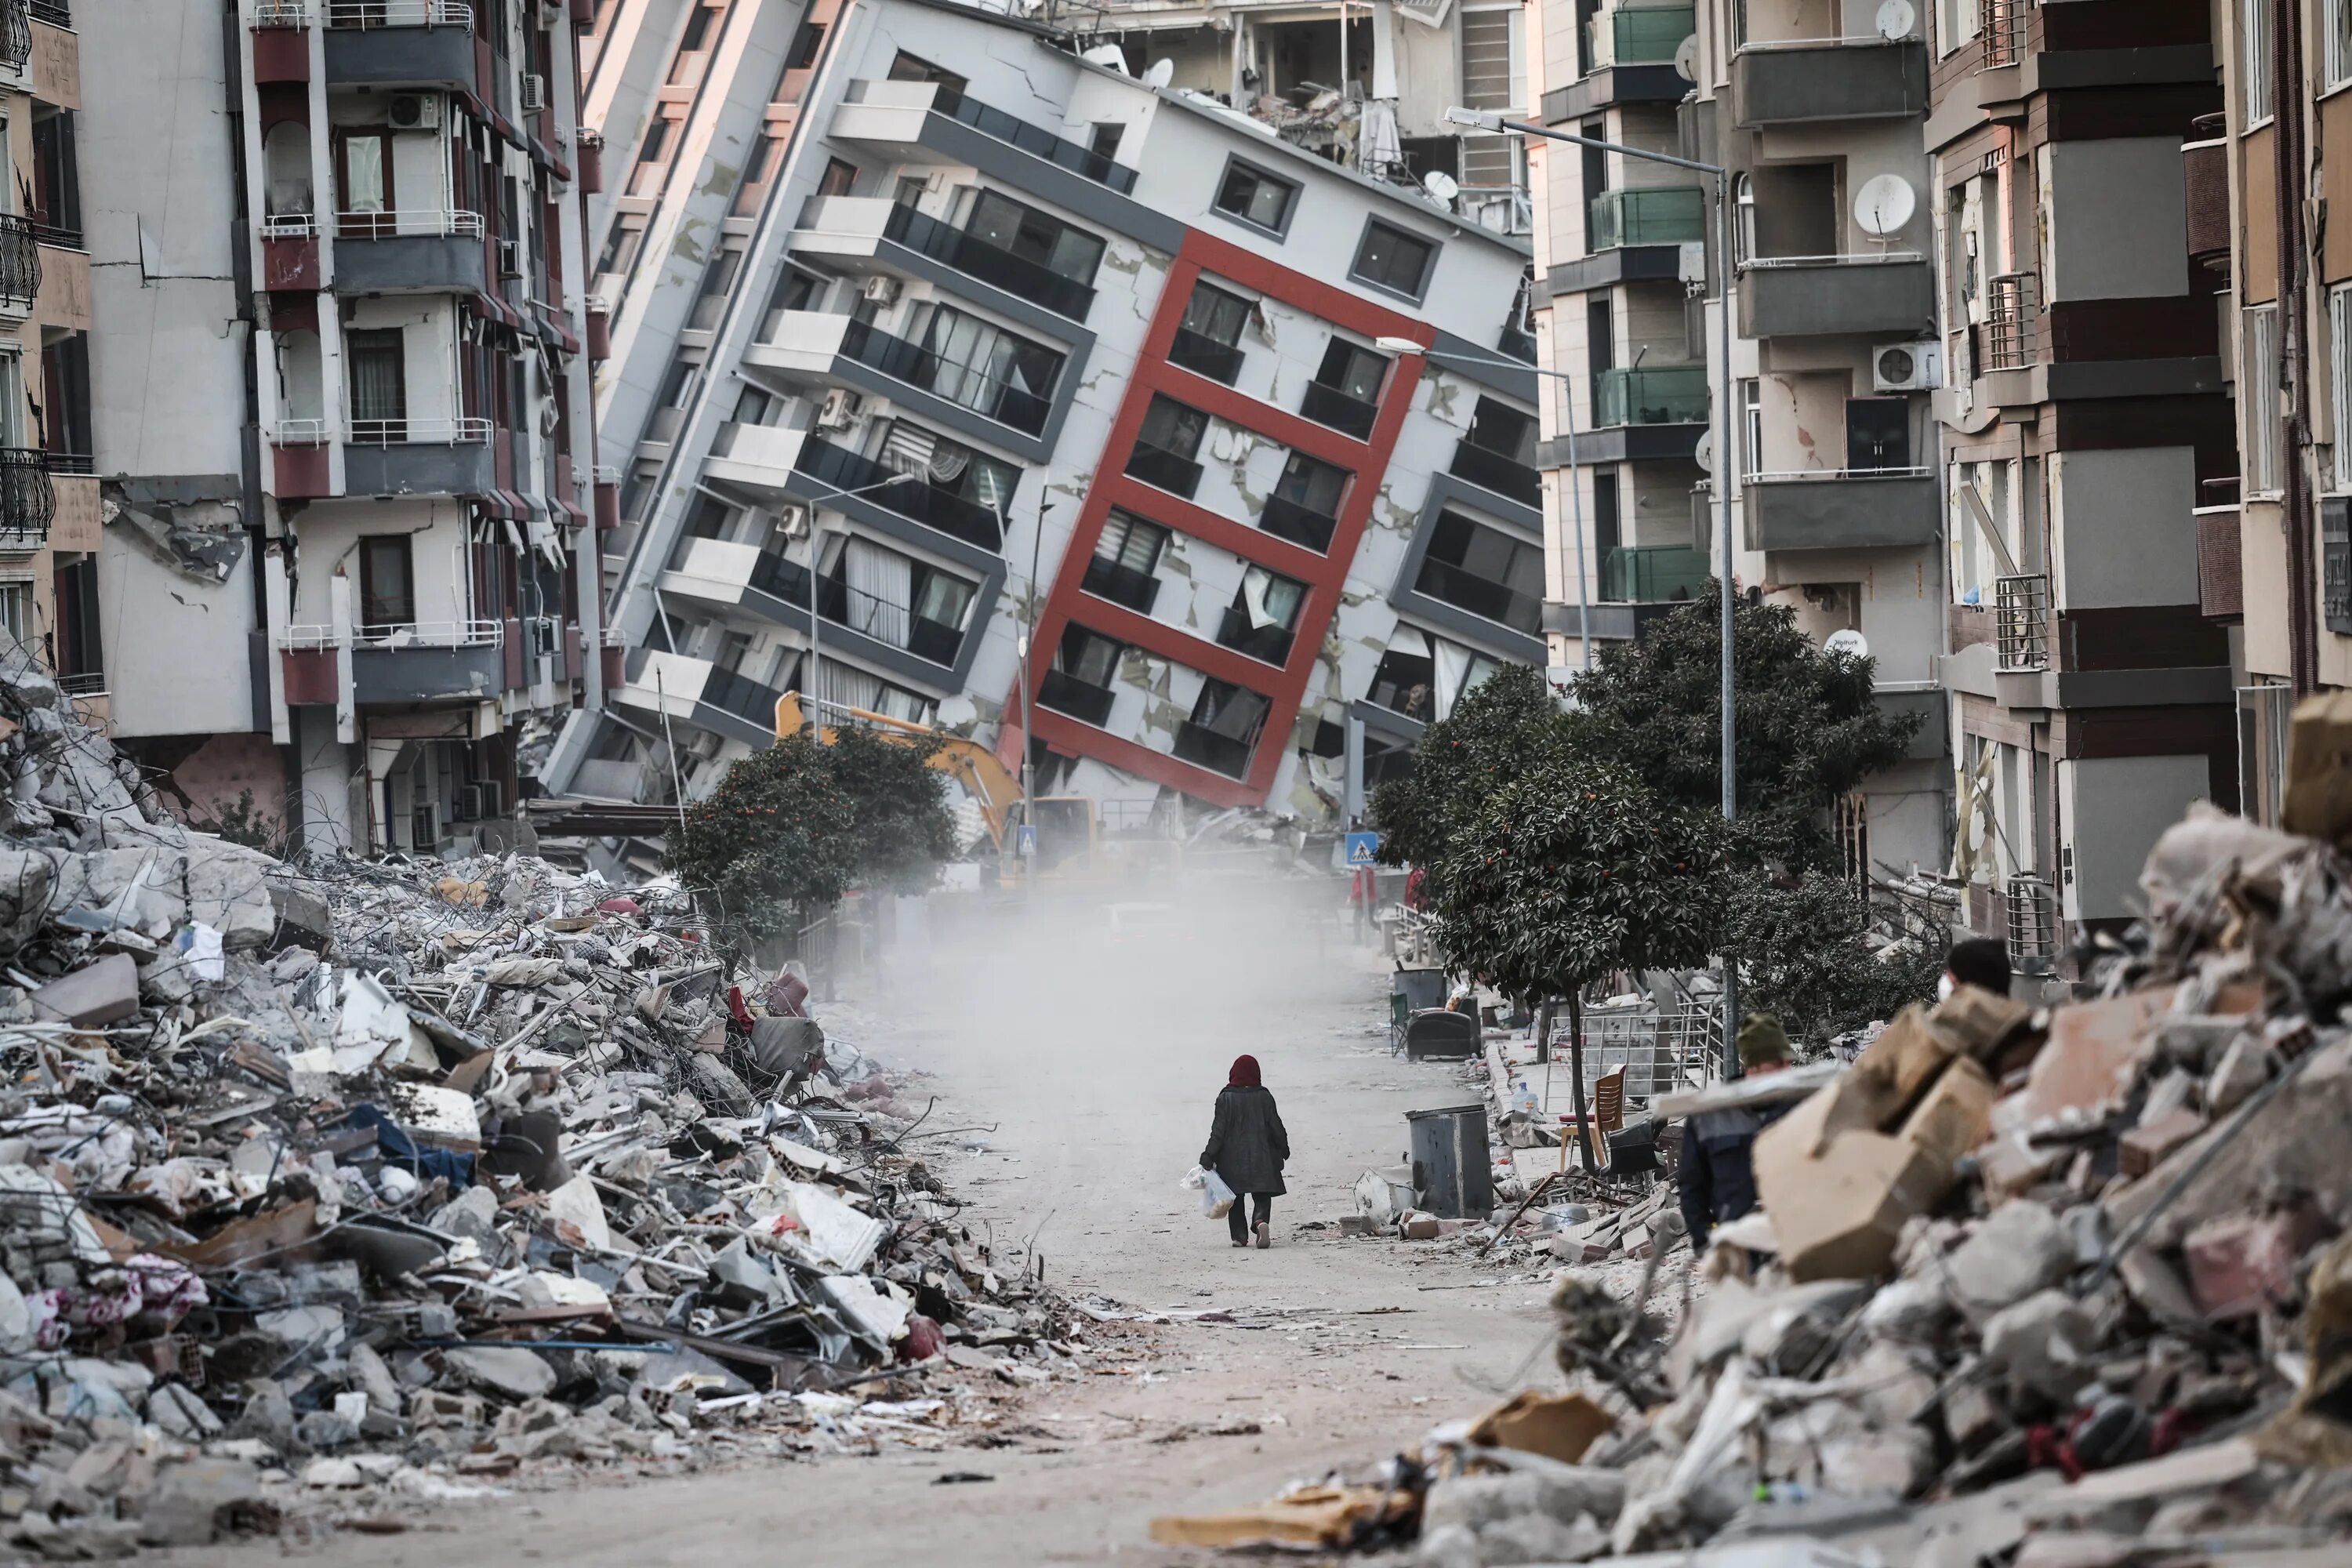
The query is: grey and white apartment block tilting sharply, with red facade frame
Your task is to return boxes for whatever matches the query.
[550,0,1543,818]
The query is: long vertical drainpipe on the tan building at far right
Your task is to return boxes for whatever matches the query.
[2270,5,2319,699]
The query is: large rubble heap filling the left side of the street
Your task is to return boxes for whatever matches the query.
[0,649,1091,1556]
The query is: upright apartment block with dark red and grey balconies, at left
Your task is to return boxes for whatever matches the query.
[75,0,597,851]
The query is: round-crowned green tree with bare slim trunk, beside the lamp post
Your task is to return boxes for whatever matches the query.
[1437,757,1726,1168]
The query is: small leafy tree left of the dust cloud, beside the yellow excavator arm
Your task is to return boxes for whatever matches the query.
[670,729,955,940]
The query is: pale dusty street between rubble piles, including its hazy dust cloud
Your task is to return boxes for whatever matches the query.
[181,884,1557,1568]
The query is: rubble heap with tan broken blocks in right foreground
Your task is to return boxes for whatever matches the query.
[1164,792,2352,1568]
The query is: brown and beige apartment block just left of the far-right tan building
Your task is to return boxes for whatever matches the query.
[1926,0,2230,968]
